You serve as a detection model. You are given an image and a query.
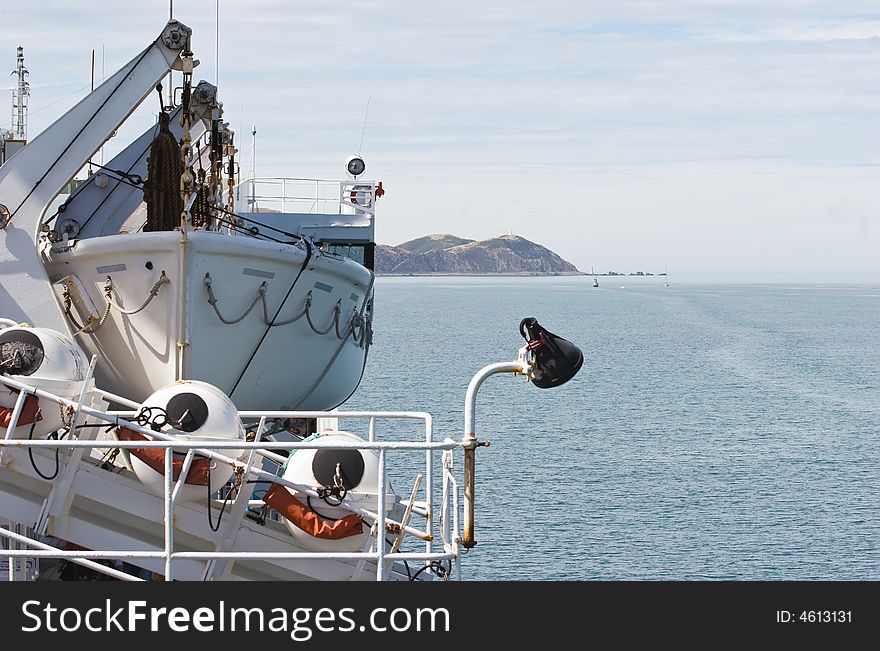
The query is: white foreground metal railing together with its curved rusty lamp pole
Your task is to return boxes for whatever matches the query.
[0,328,544,581]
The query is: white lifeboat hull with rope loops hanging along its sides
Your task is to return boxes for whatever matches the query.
[44,230,372,410]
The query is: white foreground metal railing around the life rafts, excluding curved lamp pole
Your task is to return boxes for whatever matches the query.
[0,376,467,581]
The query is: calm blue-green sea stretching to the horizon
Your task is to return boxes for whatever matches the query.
[344,277,880,580]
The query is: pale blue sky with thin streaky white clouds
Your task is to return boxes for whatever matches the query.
[0,0,880,281]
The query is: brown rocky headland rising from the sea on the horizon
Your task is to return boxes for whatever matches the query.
[376,235,579,274]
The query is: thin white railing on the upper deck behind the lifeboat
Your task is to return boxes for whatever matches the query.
[235,177,379,219]
